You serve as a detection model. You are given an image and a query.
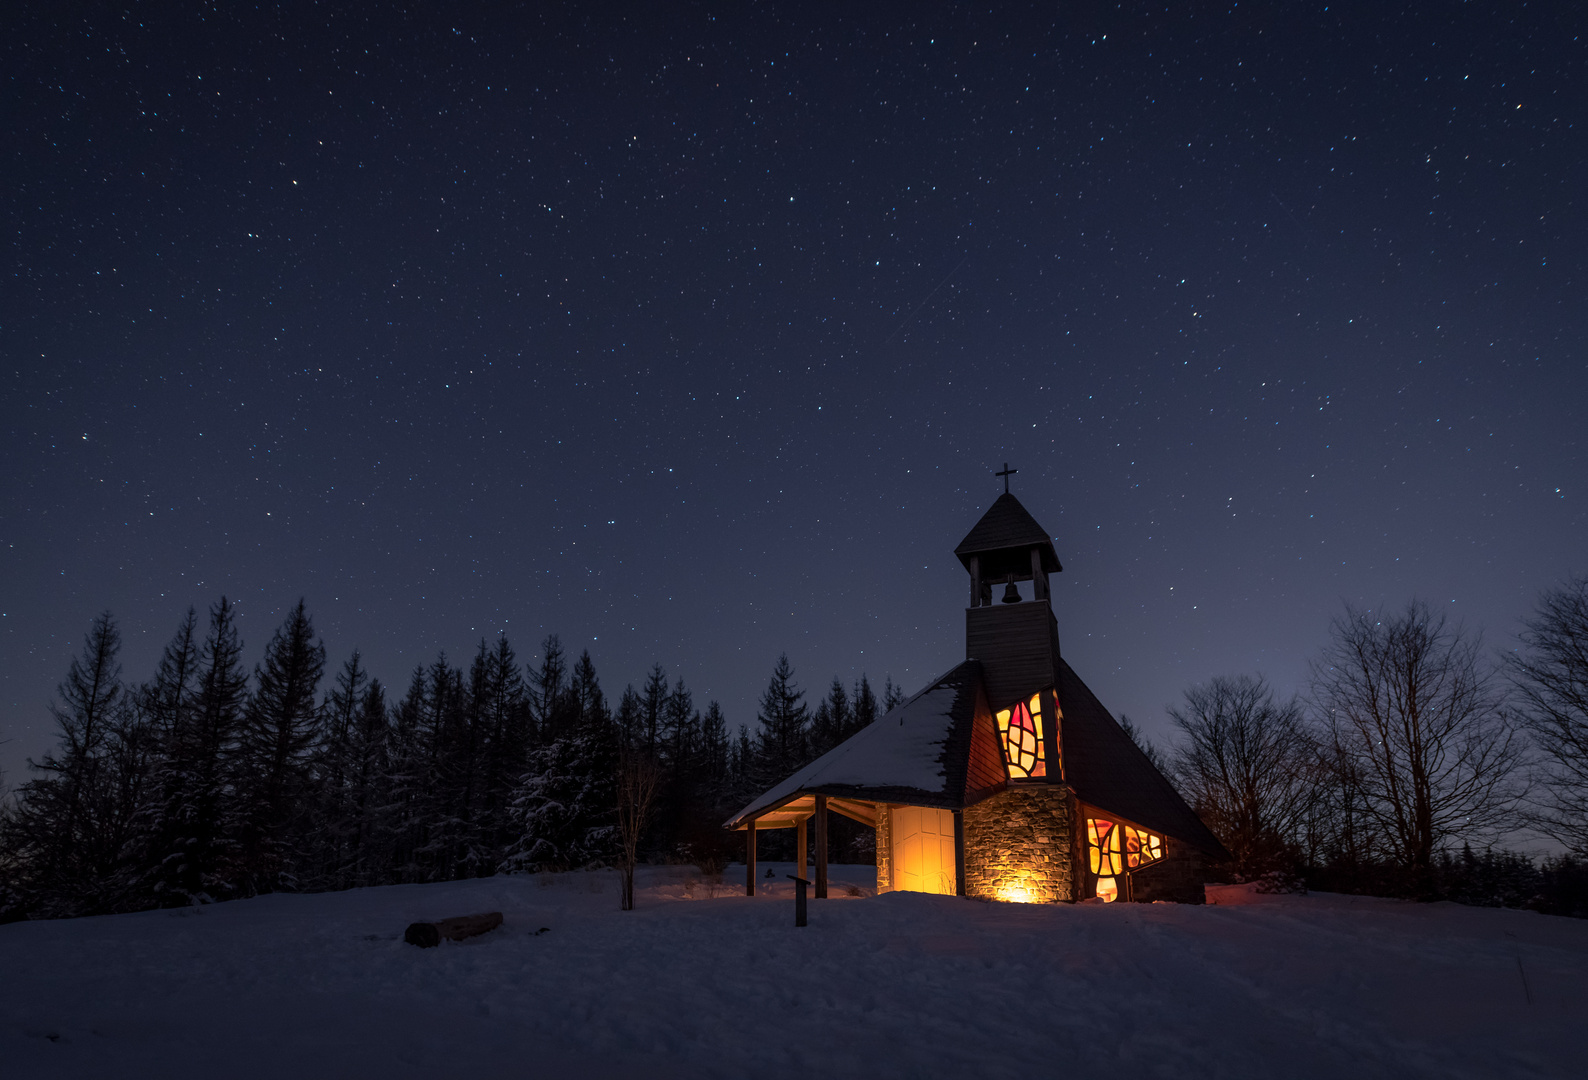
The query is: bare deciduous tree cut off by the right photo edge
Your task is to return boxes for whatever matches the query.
[1507,577,1588,854]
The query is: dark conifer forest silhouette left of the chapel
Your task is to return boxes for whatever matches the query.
[0,599,902,920]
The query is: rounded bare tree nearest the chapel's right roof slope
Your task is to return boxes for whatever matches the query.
[1169,675,1313,880]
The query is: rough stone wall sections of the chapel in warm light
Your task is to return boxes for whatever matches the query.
[959,783,1075,904]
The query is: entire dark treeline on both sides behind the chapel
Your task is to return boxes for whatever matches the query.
[0,577,1588,918]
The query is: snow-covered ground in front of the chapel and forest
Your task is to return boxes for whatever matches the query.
[0,866,1588,1080]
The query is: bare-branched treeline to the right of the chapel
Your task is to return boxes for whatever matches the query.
[1126,578,1588,915]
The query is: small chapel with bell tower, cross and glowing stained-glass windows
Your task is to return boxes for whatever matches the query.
[726,479,1229,904]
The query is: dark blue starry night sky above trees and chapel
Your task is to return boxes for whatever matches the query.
[0,3,1588,785]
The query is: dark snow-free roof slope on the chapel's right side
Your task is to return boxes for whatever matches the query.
[1058,659,1229,859]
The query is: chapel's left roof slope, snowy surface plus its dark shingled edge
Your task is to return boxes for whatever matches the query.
[724,661,981,829]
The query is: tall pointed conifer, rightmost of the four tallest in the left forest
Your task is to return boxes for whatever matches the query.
[237,600,326,893]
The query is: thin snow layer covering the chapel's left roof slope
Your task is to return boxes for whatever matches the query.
[726,661,980,829]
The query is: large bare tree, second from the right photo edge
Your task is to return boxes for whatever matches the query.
[1312,600,1524,877]
